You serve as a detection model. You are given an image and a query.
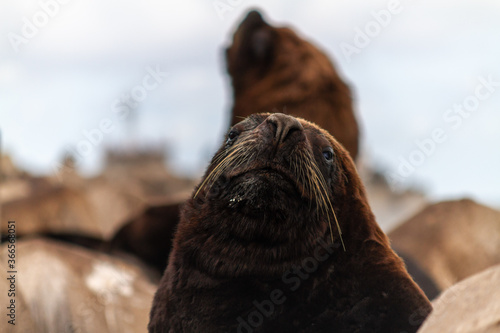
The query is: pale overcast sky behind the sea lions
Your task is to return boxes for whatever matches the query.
[0,0,500,206]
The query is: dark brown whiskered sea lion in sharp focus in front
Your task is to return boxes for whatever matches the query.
[148,114,431,333]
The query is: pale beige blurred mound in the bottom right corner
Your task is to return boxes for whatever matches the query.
[418,265,500,333]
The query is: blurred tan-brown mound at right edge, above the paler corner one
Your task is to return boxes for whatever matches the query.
[390,200,500,290]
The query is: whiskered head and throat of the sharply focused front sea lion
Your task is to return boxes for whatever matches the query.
[178,113,370,276]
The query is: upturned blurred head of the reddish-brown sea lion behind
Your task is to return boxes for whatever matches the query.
[226,10,340,94]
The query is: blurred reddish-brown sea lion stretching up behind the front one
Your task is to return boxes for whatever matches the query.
[226,11,359,158]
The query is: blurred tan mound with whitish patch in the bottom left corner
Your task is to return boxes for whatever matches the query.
[0,239,156,333]
